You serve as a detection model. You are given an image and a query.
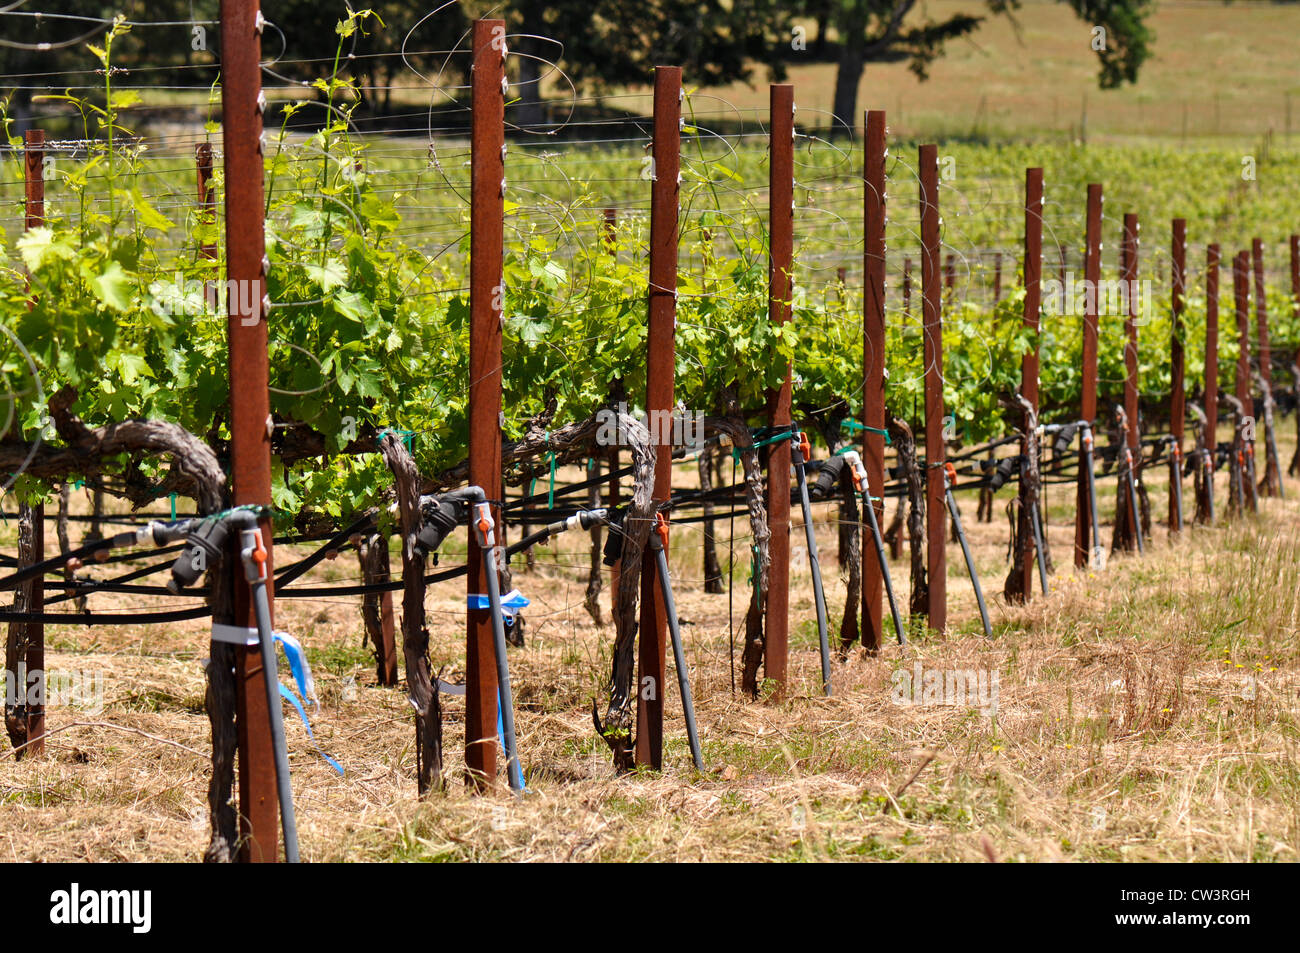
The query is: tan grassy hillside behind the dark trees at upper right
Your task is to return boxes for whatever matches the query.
[707,0,1300,142]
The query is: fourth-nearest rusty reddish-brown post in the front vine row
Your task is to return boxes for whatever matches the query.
[763,83,794,701]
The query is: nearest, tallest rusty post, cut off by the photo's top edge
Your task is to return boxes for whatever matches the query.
[221,0,280,861]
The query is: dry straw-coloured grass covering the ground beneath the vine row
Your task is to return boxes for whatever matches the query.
[0,442,1300,861]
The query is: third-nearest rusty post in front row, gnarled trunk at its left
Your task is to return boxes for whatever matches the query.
[636,66,681,770]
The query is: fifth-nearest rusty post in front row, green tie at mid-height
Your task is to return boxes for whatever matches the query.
[862,109,900,655]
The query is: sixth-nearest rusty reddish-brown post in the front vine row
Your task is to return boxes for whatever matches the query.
[920,144,948,633]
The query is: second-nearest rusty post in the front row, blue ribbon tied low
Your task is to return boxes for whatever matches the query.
[465,20,506,790]
